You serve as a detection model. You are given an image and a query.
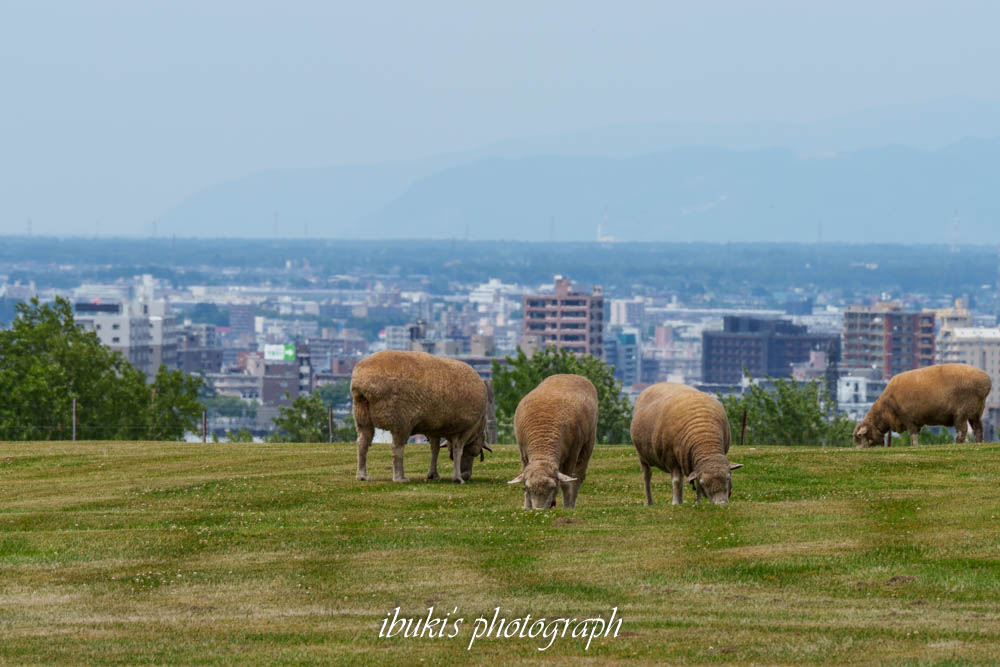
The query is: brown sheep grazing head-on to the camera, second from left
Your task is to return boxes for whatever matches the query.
[508,374,597,510]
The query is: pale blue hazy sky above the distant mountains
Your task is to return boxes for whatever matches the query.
[0,0,1000,234]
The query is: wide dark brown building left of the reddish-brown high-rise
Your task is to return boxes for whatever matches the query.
[701,315,840,385]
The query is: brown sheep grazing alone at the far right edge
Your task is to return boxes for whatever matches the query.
[854,364,992,447]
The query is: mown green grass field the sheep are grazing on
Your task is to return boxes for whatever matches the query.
[0,443,1000,664]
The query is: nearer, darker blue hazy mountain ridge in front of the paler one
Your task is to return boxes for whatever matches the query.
[359,140,1000,243]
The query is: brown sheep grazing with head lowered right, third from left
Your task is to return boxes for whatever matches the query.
[630,382,743,505]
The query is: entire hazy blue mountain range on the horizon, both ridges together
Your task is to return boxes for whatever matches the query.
[159,99,1000,243]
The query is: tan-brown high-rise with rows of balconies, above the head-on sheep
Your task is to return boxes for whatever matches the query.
[521,276,604,358]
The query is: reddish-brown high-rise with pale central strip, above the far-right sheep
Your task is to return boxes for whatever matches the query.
[841,302,935,380]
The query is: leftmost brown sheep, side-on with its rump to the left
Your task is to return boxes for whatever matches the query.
[351,350,493,484]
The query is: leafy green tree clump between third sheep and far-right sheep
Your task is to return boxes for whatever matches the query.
[719,378,854,446]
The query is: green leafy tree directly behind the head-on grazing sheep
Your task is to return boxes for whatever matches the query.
[493,347,632,443]
